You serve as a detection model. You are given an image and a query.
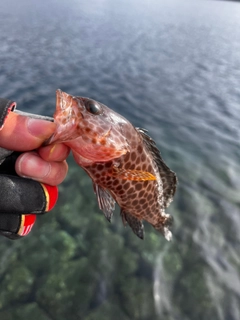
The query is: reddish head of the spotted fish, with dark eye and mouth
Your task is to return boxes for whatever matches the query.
[48,89,131,162]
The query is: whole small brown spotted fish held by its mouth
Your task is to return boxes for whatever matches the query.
[49,89,177,240]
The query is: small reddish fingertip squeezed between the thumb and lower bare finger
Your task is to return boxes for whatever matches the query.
[38,143,70,161]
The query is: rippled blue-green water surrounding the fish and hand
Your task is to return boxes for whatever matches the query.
[0,0,240,320]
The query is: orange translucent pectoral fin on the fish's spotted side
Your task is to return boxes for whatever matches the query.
[110,166,157,181]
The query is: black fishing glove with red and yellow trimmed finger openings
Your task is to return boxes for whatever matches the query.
[0,98,58,239]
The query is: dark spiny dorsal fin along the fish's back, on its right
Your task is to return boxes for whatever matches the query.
[136,128,177,208]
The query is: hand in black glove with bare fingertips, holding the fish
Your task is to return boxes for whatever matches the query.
[0,99,69,238]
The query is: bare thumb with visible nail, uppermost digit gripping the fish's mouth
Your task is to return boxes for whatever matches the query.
[0,112,56,151]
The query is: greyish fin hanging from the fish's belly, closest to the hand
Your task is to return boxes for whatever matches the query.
[93,184,115,222]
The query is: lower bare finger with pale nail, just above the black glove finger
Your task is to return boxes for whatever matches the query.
[15,152,68,186]
